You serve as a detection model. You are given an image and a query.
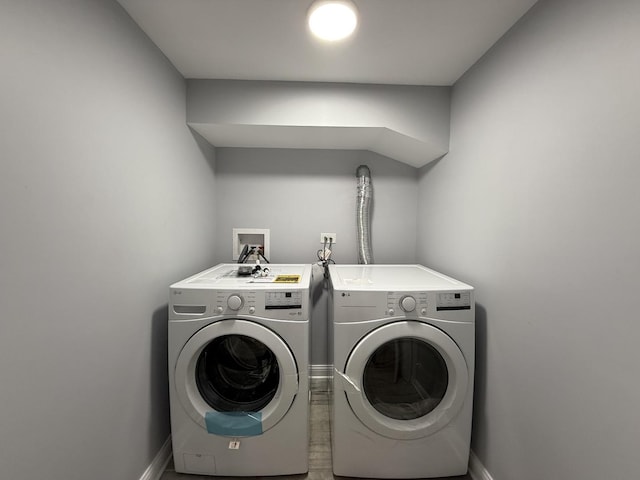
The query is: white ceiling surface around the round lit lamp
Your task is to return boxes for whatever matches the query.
[118,0,537,85]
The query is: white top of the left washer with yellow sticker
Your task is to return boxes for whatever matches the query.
[171,263,311,290]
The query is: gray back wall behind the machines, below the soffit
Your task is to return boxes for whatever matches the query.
[215,148,418,365]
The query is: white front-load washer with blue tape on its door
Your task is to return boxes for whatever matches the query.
[168,264,311,476]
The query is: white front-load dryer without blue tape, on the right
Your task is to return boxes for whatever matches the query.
[329,265,475,478]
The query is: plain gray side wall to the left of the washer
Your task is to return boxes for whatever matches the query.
[0,0,215,480]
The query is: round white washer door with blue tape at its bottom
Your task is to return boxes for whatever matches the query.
[175,319,298,437]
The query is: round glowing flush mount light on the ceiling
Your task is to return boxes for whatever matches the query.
[307,0,358,42]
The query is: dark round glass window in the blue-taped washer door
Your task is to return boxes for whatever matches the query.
[195,335,280,412]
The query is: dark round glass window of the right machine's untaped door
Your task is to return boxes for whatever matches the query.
[363,338,449,420]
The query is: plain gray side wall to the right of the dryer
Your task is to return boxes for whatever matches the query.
[418,0,640,480]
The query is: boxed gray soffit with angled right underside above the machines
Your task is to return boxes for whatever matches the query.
[187,80,450,168]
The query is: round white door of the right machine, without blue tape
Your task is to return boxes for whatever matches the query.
[343,321,469,440]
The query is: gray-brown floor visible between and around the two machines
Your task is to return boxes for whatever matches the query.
[160,379,471,480]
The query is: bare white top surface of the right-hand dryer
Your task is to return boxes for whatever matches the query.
[329,265,473,291]
